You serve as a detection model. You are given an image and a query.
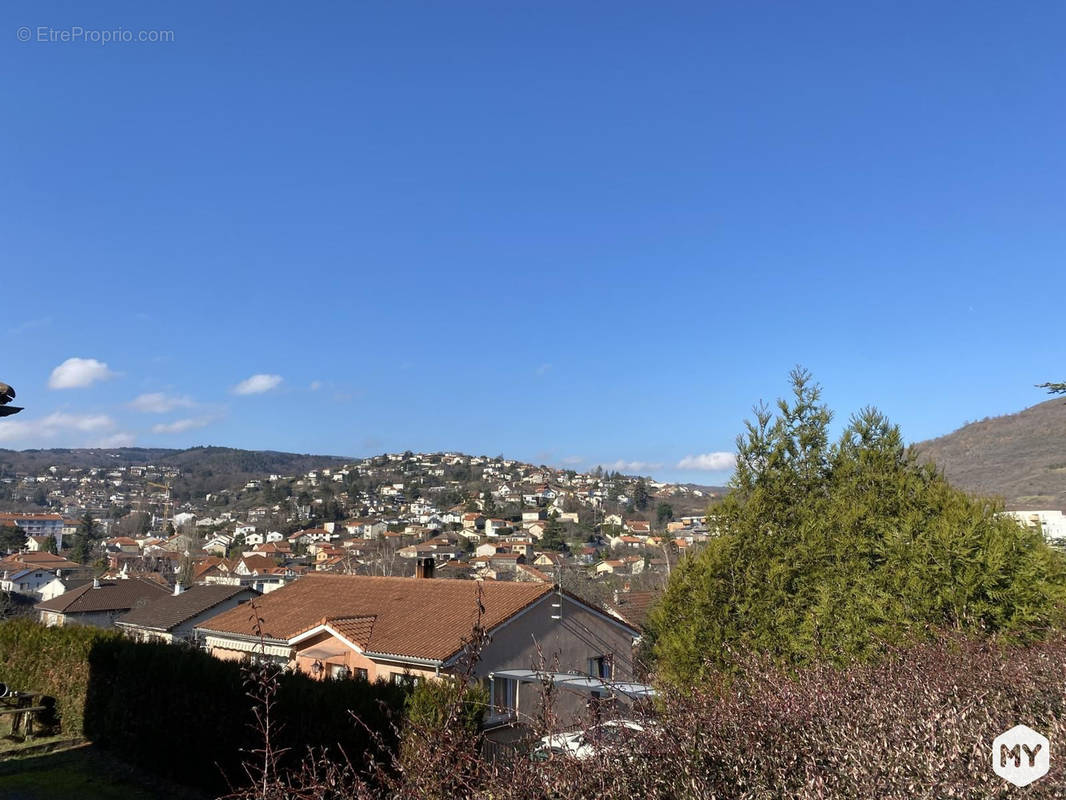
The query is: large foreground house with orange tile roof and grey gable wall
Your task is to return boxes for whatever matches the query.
[197,563,639,725]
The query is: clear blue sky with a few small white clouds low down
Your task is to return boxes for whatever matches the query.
[0,0,1066,483]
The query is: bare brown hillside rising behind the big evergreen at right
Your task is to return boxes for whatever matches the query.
[916,398,1066,511]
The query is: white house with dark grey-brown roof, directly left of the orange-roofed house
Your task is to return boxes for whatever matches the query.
[115,583,259,643]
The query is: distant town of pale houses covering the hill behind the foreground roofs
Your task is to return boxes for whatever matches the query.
[0,452,717,625]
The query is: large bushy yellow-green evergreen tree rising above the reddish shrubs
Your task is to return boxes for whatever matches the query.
[648,369,1066,684]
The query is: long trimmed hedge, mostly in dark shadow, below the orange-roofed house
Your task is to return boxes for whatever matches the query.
[0,620,407,790]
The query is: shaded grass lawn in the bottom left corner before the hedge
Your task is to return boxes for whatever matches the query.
[0,745,205,800]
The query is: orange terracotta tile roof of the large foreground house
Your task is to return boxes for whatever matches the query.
[199,573,552,661]
